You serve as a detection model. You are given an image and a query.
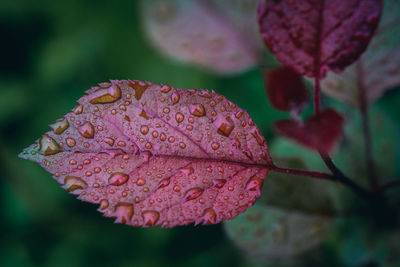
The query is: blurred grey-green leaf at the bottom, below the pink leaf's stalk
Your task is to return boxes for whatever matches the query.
[225,203,331,260]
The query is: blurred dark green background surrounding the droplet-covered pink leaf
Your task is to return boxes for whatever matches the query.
[0,0,400,266]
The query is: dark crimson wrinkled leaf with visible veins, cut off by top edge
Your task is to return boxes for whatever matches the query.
[258,0,382,77]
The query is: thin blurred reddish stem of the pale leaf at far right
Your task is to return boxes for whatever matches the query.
[357,60,378,190]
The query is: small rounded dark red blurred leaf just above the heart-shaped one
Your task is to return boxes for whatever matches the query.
[265,67,307,111]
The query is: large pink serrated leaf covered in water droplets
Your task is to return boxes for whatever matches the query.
[20,80,271,227]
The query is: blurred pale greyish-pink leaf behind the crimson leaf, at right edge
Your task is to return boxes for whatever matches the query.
[321,0,400,106]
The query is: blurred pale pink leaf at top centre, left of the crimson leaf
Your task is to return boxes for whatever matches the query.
[141,0,262,74]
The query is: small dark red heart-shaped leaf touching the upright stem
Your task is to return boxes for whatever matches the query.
[275,108,344,152]
